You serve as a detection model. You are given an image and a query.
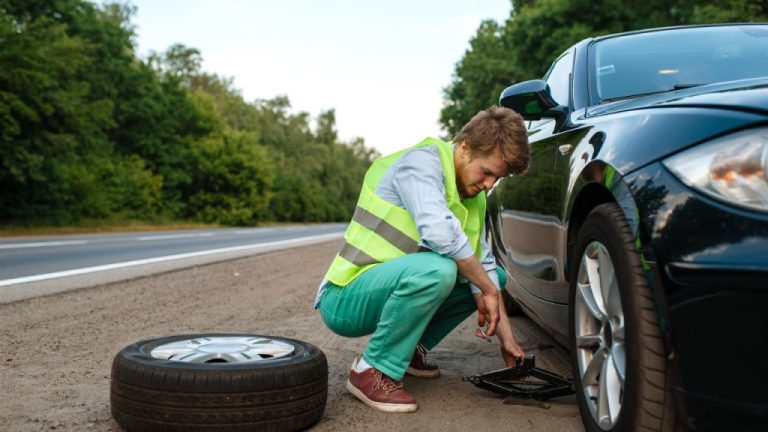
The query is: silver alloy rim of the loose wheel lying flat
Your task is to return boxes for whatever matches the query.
[149,336,294,364]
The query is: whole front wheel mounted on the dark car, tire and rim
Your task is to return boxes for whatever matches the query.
[570,203,675,432]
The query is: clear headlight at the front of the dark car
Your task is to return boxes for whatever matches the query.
[664,128,768,211]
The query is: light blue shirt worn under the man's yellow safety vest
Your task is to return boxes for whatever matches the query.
[315,146,499,308]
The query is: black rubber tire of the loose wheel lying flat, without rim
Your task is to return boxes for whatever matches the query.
[110,338,328,431]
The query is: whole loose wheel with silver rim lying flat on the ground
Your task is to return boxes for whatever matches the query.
[110,333,328,431]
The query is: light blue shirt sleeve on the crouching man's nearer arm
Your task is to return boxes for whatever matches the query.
[391,149,474,259]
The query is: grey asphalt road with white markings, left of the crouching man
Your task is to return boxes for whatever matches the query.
[0,224,345,303]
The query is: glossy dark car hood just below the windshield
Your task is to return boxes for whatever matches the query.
[587,77,768,117]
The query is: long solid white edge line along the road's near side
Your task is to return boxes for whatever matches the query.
[0,233,343,286]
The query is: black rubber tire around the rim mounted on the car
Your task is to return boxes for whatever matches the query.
[569,203,678,432]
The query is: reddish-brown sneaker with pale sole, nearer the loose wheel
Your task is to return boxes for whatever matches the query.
[347,357,418,412]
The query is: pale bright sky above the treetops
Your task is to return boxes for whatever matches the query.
[124,0,511,154]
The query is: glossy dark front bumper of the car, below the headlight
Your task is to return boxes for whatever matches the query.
[625,163,768,431]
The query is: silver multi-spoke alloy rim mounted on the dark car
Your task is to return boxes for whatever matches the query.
[574,241,626,430]
